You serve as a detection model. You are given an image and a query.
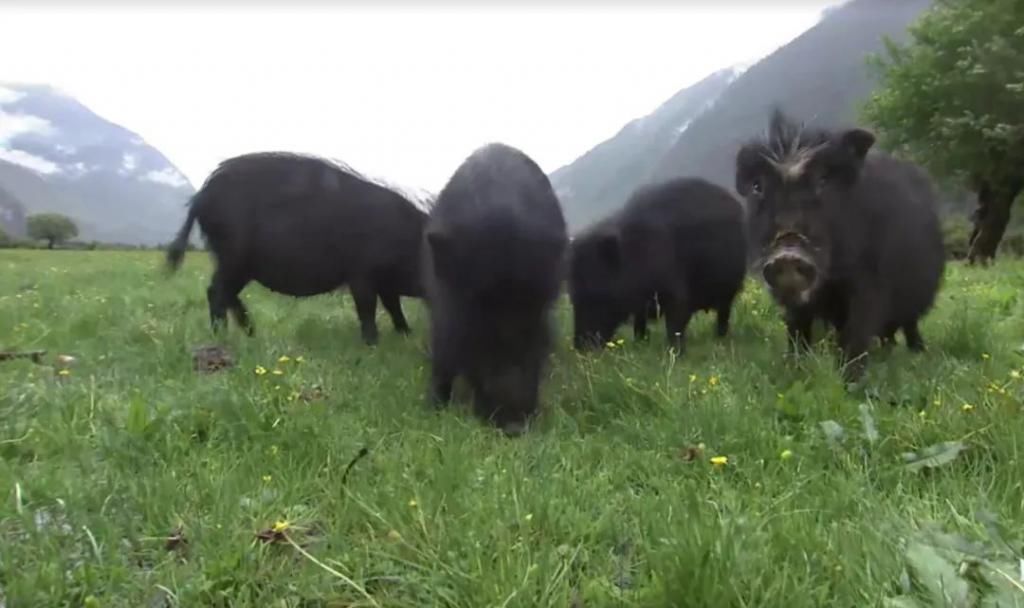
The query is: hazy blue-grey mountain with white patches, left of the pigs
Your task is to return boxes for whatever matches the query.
[0,84,195,245]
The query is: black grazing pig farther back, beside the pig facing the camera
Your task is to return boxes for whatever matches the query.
[569,177,746,350]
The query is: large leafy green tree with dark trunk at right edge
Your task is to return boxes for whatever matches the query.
[863,0,1024,263]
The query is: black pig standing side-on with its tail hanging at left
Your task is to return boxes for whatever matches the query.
[167,153,427,344]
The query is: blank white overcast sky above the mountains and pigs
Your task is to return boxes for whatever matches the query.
[0,0,837,191]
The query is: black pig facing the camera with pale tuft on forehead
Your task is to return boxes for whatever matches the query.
[736,110,945,381]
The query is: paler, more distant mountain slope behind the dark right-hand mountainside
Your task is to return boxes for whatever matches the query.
[551,68,741,229]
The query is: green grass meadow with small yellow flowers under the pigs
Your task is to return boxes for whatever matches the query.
[0,251,1024,608]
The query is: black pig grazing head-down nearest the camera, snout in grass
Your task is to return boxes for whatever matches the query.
[423,143,568,435]
